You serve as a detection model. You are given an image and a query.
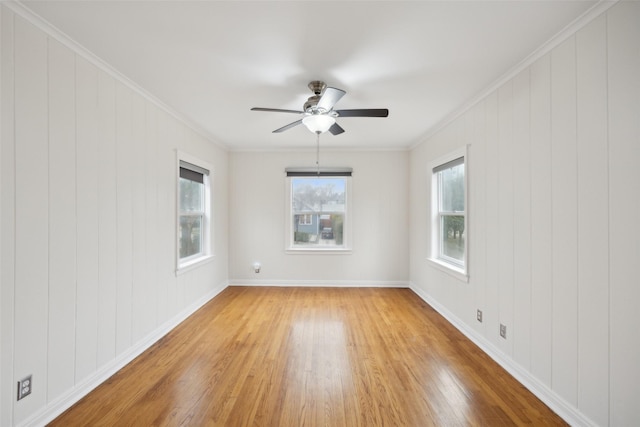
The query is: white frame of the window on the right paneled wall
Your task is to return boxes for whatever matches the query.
[428,146,470,282]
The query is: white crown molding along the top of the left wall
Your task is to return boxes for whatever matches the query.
[2,0,229,151]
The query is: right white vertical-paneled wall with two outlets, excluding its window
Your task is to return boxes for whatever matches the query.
[410,2,640,426]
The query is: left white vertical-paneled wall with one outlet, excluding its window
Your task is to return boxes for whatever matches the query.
[0,6,228,426]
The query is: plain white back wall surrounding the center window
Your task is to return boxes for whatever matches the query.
[229,149,409,286]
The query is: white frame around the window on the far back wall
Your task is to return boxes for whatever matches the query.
[284,168,353,254]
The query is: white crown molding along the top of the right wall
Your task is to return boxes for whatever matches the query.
[409,0,619,151]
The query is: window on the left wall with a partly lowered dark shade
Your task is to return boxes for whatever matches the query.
[177,153,210,270]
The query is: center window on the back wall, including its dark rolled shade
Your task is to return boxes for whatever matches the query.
[286,168,351,251]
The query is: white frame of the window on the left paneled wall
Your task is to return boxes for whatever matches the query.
[175,150,213,275]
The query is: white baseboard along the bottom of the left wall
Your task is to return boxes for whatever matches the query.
[18,282,228,427]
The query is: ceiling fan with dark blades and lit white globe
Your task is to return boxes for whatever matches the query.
[251,80,389,135]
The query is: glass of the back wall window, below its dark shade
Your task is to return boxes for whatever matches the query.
[291,177,346,246]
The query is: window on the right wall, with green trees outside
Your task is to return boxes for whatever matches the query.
[431,150,467,278]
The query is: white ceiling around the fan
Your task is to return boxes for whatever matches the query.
[23,0,596,150]
